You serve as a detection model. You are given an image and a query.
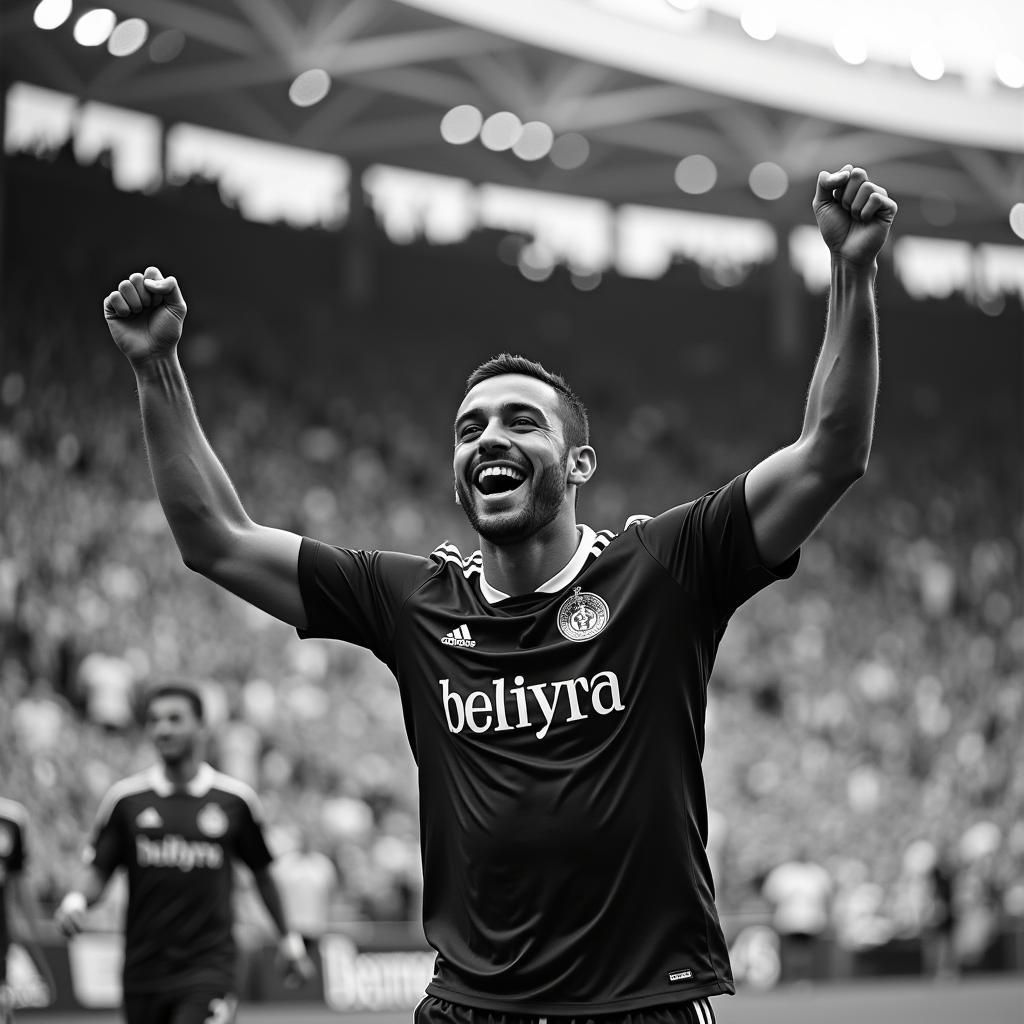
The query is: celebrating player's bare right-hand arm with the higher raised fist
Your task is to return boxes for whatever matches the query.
[744,164,897,566]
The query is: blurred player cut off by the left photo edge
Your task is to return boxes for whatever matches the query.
[0,797,54,1024]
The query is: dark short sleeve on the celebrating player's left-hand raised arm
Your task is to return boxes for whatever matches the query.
[298,538,436,662]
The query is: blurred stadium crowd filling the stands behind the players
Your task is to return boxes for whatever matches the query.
[0,146,1024,964]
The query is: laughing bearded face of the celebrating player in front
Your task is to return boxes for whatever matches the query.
[455,374,593,544]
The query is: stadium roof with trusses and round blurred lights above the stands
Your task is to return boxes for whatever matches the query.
[0,0,1024,243]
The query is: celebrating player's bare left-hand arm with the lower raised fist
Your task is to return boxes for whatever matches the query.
[103,267,306,628]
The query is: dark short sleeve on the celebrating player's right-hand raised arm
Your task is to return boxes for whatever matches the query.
[635,473,800,623]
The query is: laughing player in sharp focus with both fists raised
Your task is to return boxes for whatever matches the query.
[104,165,896,1024]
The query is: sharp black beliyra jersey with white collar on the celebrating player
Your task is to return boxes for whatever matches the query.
[299,477,797,1015]
